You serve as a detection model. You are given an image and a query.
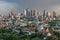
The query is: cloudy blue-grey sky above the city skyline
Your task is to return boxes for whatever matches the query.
[0,0,60,15]
